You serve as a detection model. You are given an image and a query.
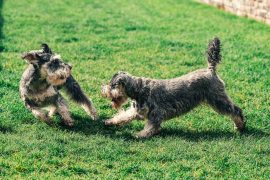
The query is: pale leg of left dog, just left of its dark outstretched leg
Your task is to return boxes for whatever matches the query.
[56,94,74,126]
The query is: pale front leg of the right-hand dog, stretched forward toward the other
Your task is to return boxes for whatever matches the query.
[105,105,139,125]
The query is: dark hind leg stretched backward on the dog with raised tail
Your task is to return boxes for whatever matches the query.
[207,92,245,131]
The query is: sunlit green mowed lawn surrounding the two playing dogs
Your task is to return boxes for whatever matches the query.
[0,0,270,179]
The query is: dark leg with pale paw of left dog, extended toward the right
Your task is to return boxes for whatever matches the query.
[64,76,98,120]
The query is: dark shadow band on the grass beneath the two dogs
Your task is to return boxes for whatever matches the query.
[60,115,270,141]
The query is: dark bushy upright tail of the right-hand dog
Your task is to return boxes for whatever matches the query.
[206,37,221,71]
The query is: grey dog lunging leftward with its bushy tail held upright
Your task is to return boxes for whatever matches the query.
[102,38,245,137]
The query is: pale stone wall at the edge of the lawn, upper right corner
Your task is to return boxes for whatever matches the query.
[199,0,270,24]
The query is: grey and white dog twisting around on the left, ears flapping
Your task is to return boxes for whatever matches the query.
[20,44,98,126]
